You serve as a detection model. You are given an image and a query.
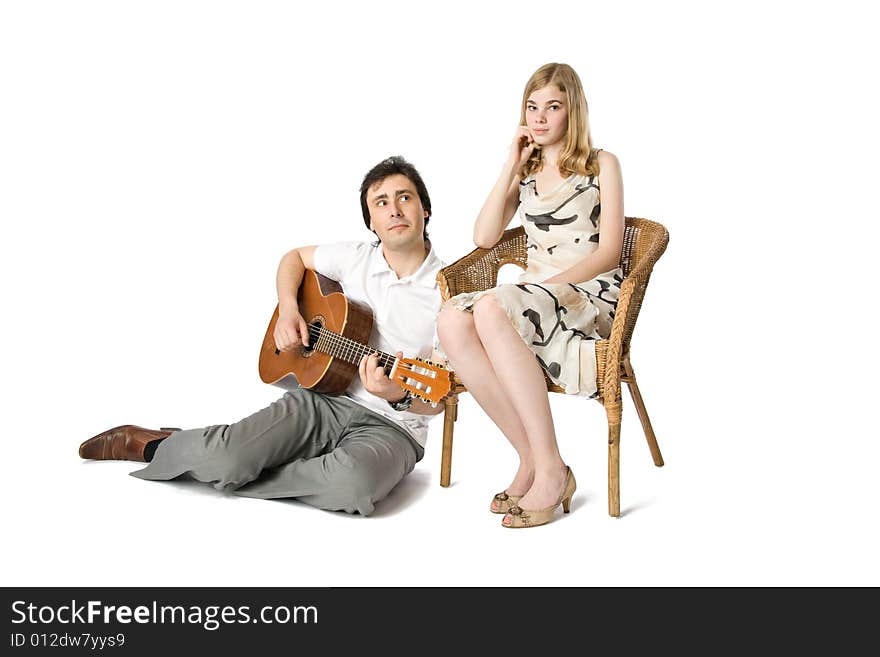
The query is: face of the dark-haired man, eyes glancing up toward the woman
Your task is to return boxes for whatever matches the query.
[367,173,428,249]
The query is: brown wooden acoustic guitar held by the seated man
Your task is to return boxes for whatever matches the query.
[253,269,452,405]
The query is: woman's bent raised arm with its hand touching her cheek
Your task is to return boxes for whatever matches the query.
[474,126,535,249]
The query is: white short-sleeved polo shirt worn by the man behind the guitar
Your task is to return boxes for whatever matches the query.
[314,242,445,447]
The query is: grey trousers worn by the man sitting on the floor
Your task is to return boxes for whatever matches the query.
[131,388,424,516]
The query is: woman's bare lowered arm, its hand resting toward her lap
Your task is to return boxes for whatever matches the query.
[544,151,626,283]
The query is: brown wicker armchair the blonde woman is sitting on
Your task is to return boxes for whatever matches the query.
[437,217,669,517]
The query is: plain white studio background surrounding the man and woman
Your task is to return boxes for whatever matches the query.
[0,1,880,586]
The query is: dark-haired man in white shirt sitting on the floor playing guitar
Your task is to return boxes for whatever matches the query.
[79,157,443,516]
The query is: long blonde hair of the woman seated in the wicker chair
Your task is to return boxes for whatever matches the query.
[519,63,599,178]
